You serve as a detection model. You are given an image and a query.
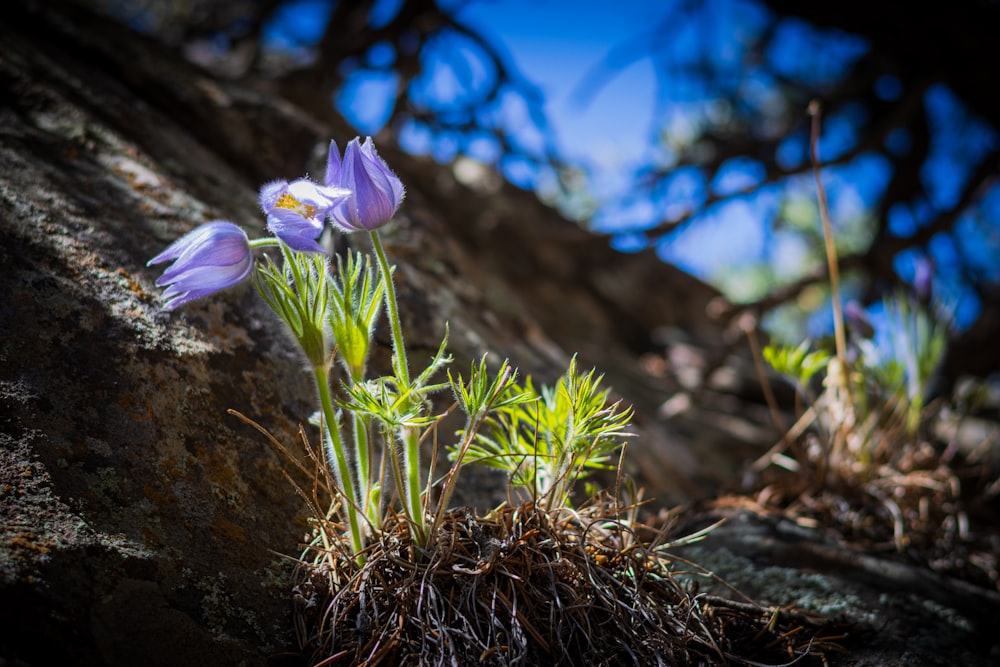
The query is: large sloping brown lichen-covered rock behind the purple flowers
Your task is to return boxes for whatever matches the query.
[0,2,736,665]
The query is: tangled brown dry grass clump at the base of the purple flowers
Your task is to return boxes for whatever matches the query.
[296,498,837,666]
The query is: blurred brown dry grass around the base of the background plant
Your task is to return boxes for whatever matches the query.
[746,431,1000,590]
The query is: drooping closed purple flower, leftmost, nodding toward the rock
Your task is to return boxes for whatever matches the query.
[146,220,253,310]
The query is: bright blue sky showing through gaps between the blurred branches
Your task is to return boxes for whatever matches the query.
[262,0,1000,340]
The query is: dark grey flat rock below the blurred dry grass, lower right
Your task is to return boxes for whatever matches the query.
[671,509,1000,667]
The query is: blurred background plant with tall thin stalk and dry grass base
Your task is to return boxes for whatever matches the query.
[745,130,1000,587]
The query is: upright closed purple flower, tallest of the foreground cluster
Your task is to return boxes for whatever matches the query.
[325,137,404,232]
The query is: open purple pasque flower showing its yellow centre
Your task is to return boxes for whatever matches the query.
[260,178,350,252]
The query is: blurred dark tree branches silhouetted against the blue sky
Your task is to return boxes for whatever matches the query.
[84,0,1000,380]
